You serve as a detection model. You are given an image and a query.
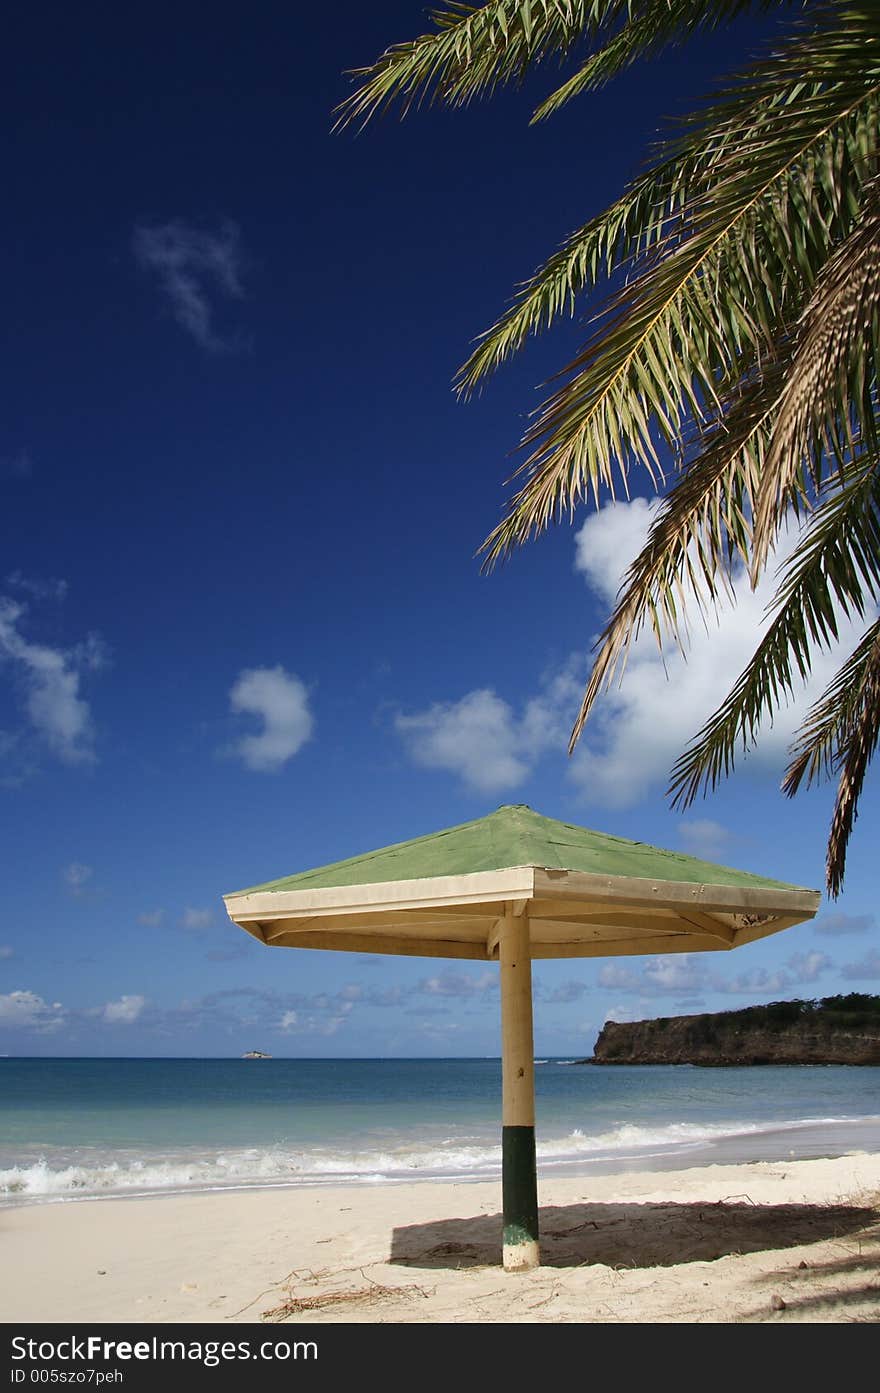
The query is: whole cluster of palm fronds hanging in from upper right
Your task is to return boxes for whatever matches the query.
[338,0,880,893]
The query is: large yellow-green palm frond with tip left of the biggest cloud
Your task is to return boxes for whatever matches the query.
[482,24,880,566]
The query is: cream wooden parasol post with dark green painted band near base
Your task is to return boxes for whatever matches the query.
[498,904,540,1272]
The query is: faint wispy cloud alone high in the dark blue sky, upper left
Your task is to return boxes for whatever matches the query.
[132,219,244,352]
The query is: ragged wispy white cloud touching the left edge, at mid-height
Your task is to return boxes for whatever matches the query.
[0,598,106,765]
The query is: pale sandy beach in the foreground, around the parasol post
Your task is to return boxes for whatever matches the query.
[0,1153,880,1326]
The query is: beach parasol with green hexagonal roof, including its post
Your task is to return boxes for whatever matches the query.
[224,804,820,1270]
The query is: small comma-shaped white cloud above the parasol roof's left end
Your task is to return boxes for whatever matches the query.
[230,667,315,773]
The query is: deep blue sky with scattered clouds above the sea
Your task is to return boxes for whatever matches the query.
[0,0,880,1056]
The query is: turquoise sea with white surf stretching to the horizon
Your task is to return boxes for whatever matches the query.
[0,1057,880,1205]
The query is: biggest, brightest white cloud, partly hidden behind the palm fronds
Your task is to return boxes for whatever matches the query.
[571,499,874,807]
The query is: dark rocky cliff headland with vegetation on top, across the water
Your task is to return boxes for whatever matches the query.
[593,999,880,1064]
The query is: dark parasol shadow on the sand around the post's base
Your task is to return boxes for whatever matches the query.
[388,1195,877,1268]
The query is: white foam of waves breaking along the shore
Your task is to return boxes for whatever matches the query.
[0,1117,880,1204]
